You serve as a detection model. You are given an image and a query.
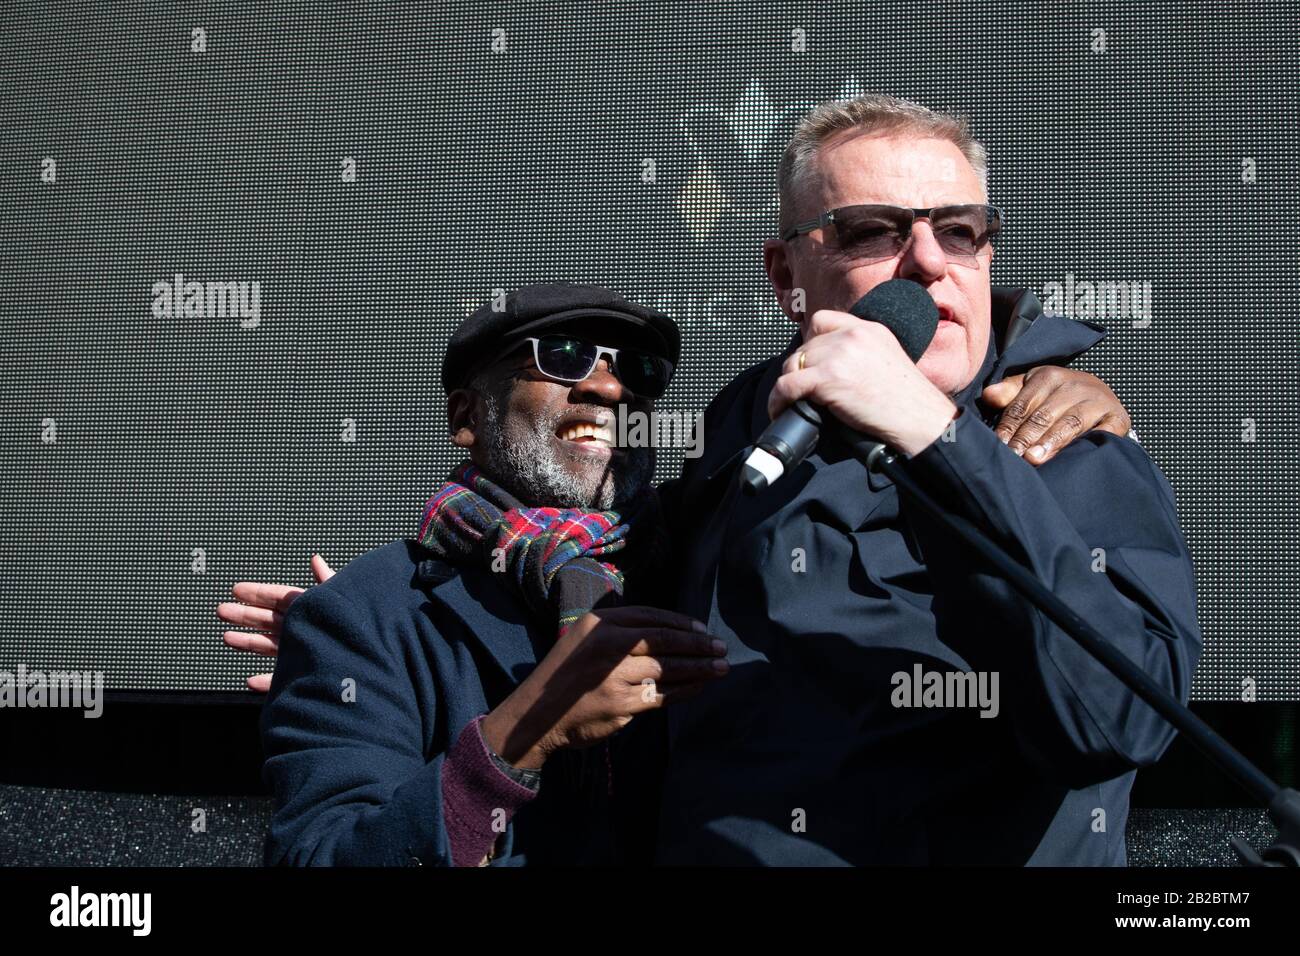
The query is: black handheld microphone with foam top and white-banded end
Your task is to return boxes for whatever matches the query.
[740,278,939,494]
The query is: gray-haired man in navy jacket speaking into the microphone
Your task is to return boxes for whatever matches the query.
[658,96,1201,865]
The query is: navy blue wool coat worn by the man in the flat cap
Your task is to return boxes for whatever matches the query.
[261,540,655,866]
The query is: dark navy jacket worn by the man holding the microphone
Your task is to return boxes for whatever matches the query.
[658,315,1201,865]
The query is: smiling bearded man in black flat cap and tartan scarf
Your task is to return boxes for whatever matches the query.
[263,284,727,865]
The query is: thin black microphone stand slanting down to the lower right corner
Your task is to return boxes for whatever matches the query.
[852,437,1300,866]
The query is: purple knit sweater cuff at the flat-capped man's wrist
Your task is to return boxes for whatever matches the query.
[442,714,537,866]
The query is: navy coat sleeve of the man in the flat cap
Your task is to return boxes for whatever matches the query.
[261,587,451,866]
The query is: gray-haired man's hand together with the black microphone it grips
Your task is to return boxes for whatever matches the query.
[741,280,957,494]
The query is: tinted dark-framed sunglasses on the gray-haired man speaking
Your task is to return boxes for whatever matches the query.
[781,203,1002,265]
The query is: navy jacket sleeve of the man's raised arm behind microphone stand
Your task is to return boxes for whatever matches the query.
[902,408,1201,787]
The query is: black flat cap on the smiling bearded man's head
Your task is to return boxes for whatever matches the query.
[442,282,681,392]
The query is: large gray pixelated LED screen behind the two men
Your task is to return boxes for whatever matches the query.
[0,0,1300,700]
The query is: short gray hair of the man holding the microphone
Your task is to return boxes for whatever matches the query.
[777,94,988,232]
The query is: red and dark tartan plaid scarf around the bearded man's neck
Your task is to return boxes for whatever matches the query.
[419,462,666,637]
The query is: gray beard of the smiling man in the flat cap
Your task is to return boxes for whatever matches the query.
[480,389,655,511]
